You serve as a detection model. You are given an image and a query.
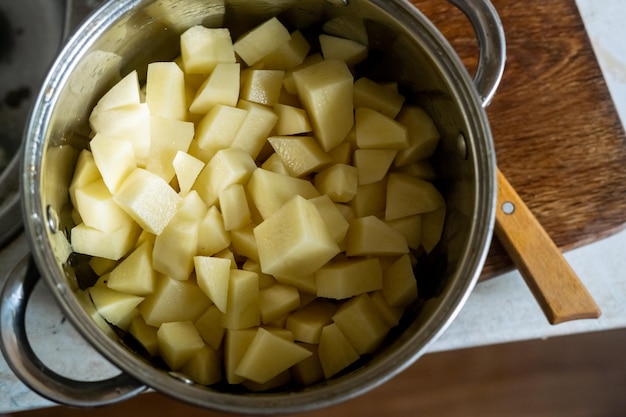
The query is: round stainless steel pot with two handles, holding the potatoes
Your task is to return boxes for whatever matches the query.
[0,0,505,414]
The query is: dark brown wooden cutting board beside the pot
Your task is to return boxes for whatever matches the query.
[412,0,626,279]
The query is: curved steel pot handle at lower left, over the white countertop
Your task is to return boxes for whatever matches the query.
[0,250,147,407]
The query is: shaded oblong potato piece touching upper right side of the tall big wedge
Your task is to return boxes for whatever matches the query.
[354,77,404,119]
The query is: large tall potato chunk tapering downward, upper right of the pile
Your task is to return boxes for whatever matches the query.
[293,60,354,151]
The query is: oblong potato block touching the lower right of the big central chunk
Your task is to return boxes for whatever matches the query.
[315,258,383,300]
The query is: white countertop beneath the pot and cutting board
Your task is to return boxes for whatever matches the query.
[0,0,626,414]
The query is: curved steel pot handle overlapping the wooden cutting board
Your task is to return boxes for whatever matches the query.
[448,0,506,107]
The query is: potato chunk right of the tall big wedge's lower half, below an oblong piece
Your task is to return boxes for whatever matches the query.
[354,107,409,150]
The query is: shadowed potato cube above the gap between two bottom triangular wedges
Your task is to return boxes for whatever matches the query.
[285,298,338,344]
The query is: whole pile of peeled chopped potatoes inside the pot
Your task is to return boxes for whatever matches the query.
[70,18,445,391]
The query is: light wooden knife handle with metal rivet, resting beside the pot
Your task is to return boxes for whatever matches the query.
[495,170,601,324]
